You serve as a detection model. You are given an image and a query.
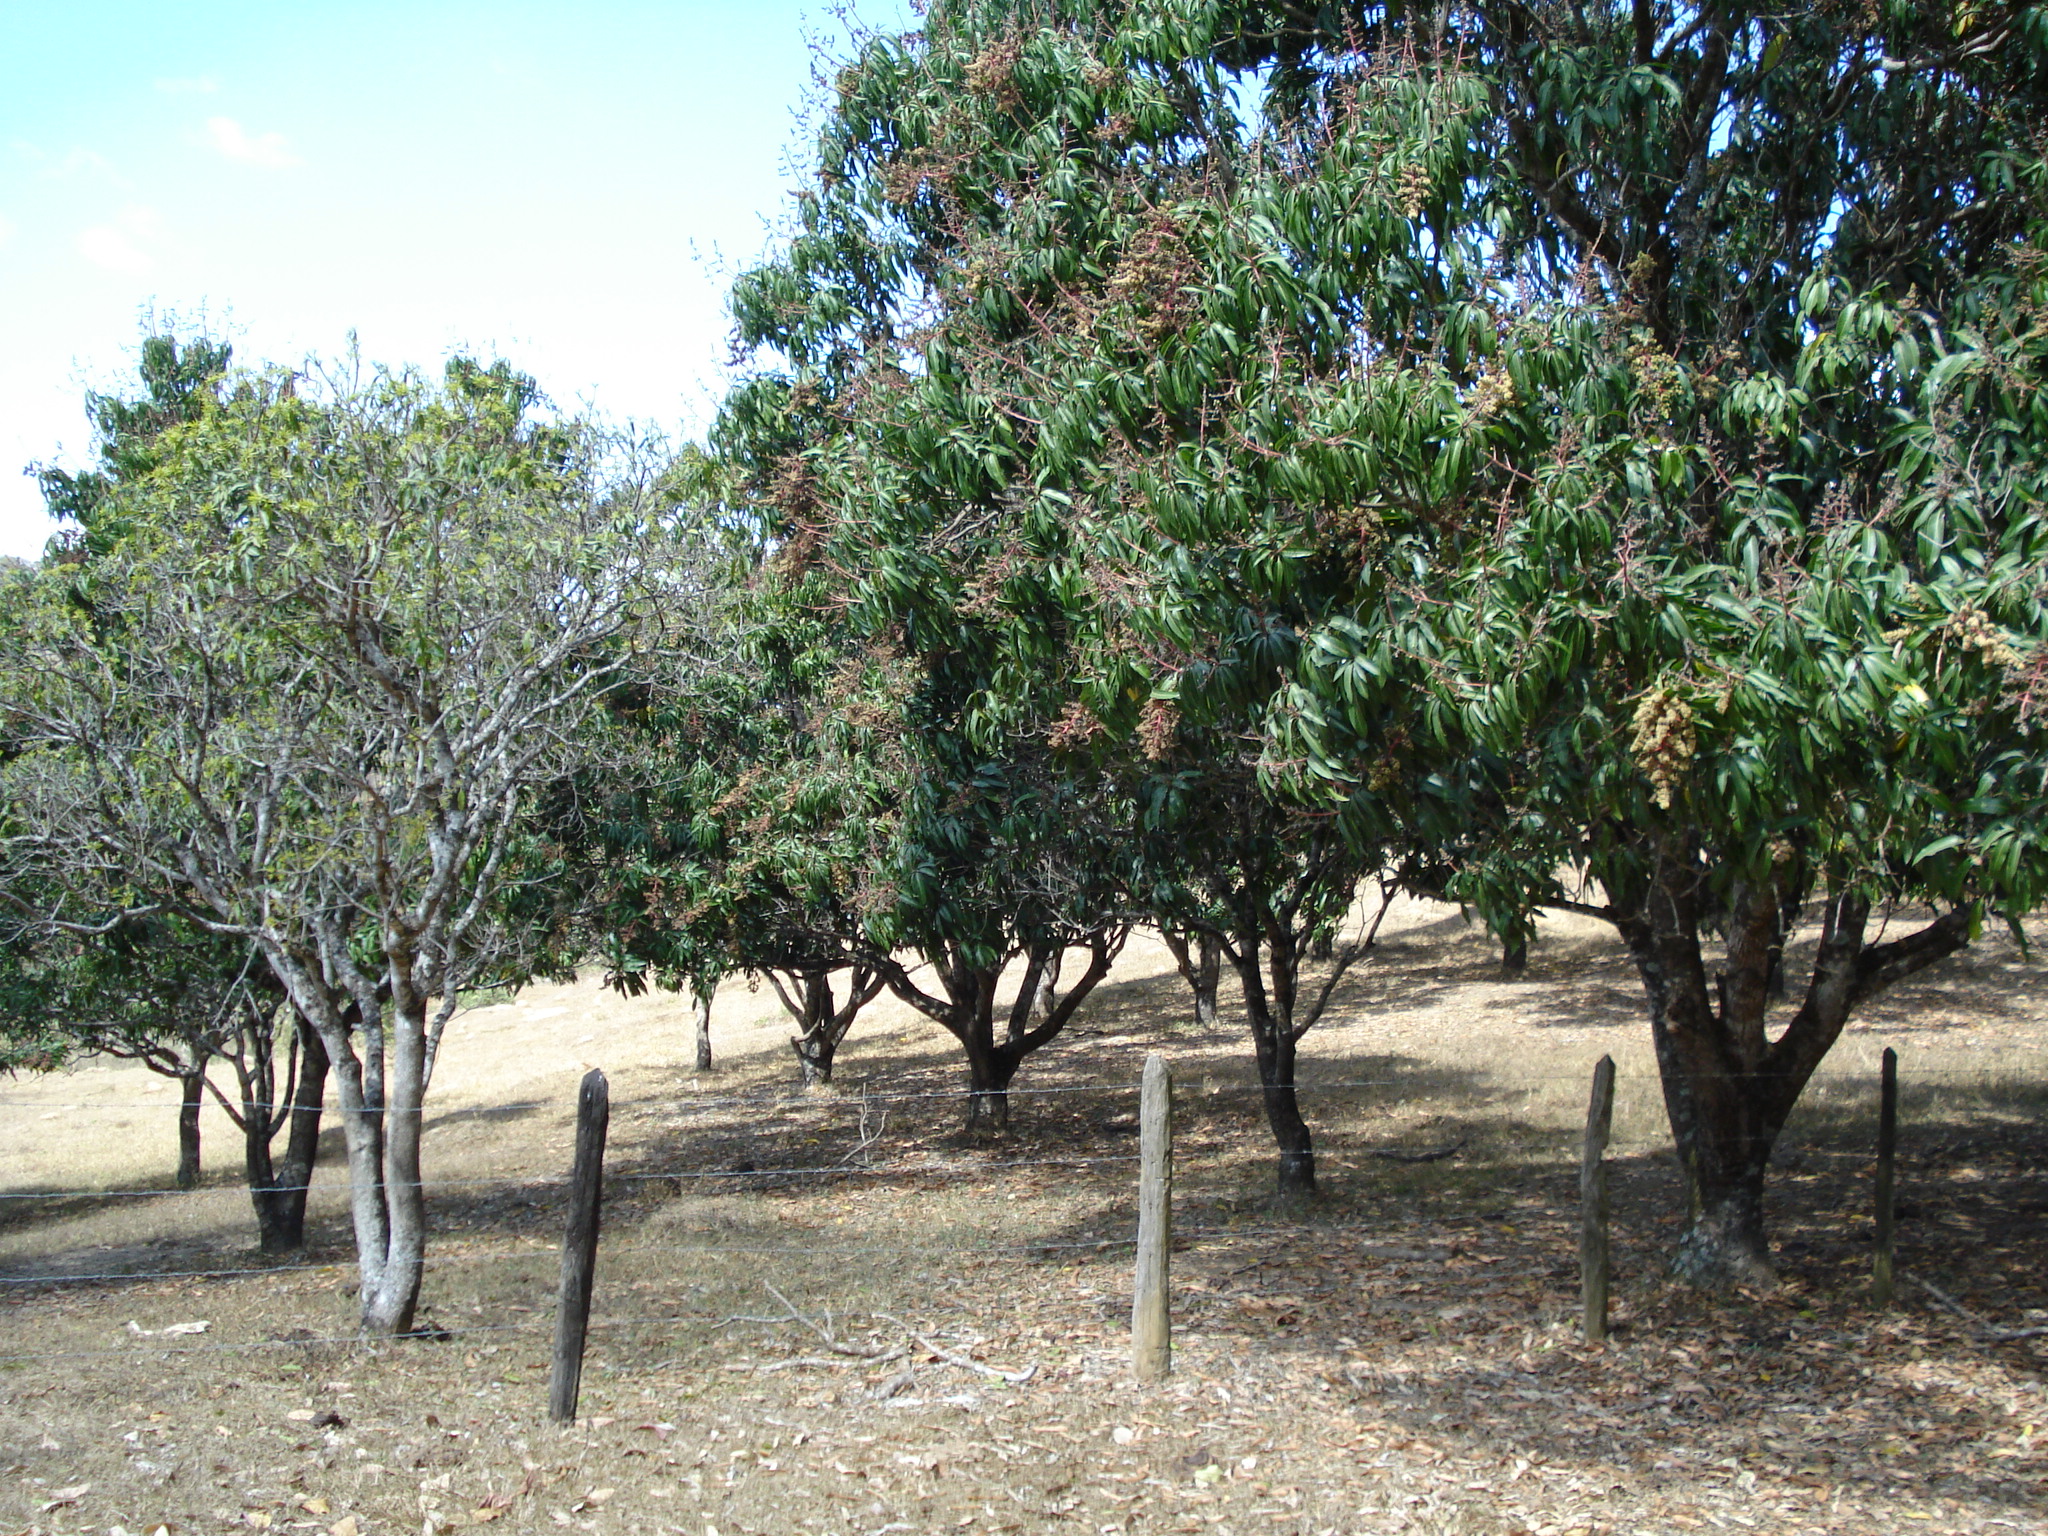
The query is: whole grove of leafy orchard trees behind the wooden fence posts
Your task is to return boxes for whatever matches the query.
[0,0,2048,1331]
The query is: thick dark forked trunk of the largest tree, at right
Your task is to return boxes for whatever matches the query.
[1604,844,1974,1288]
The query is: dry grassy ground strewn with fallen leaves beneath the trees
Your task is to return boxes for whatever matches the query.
[0,903,2048,1536]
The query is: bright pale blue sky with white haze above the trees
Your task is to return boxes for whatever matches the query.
[0,0,909,557]
